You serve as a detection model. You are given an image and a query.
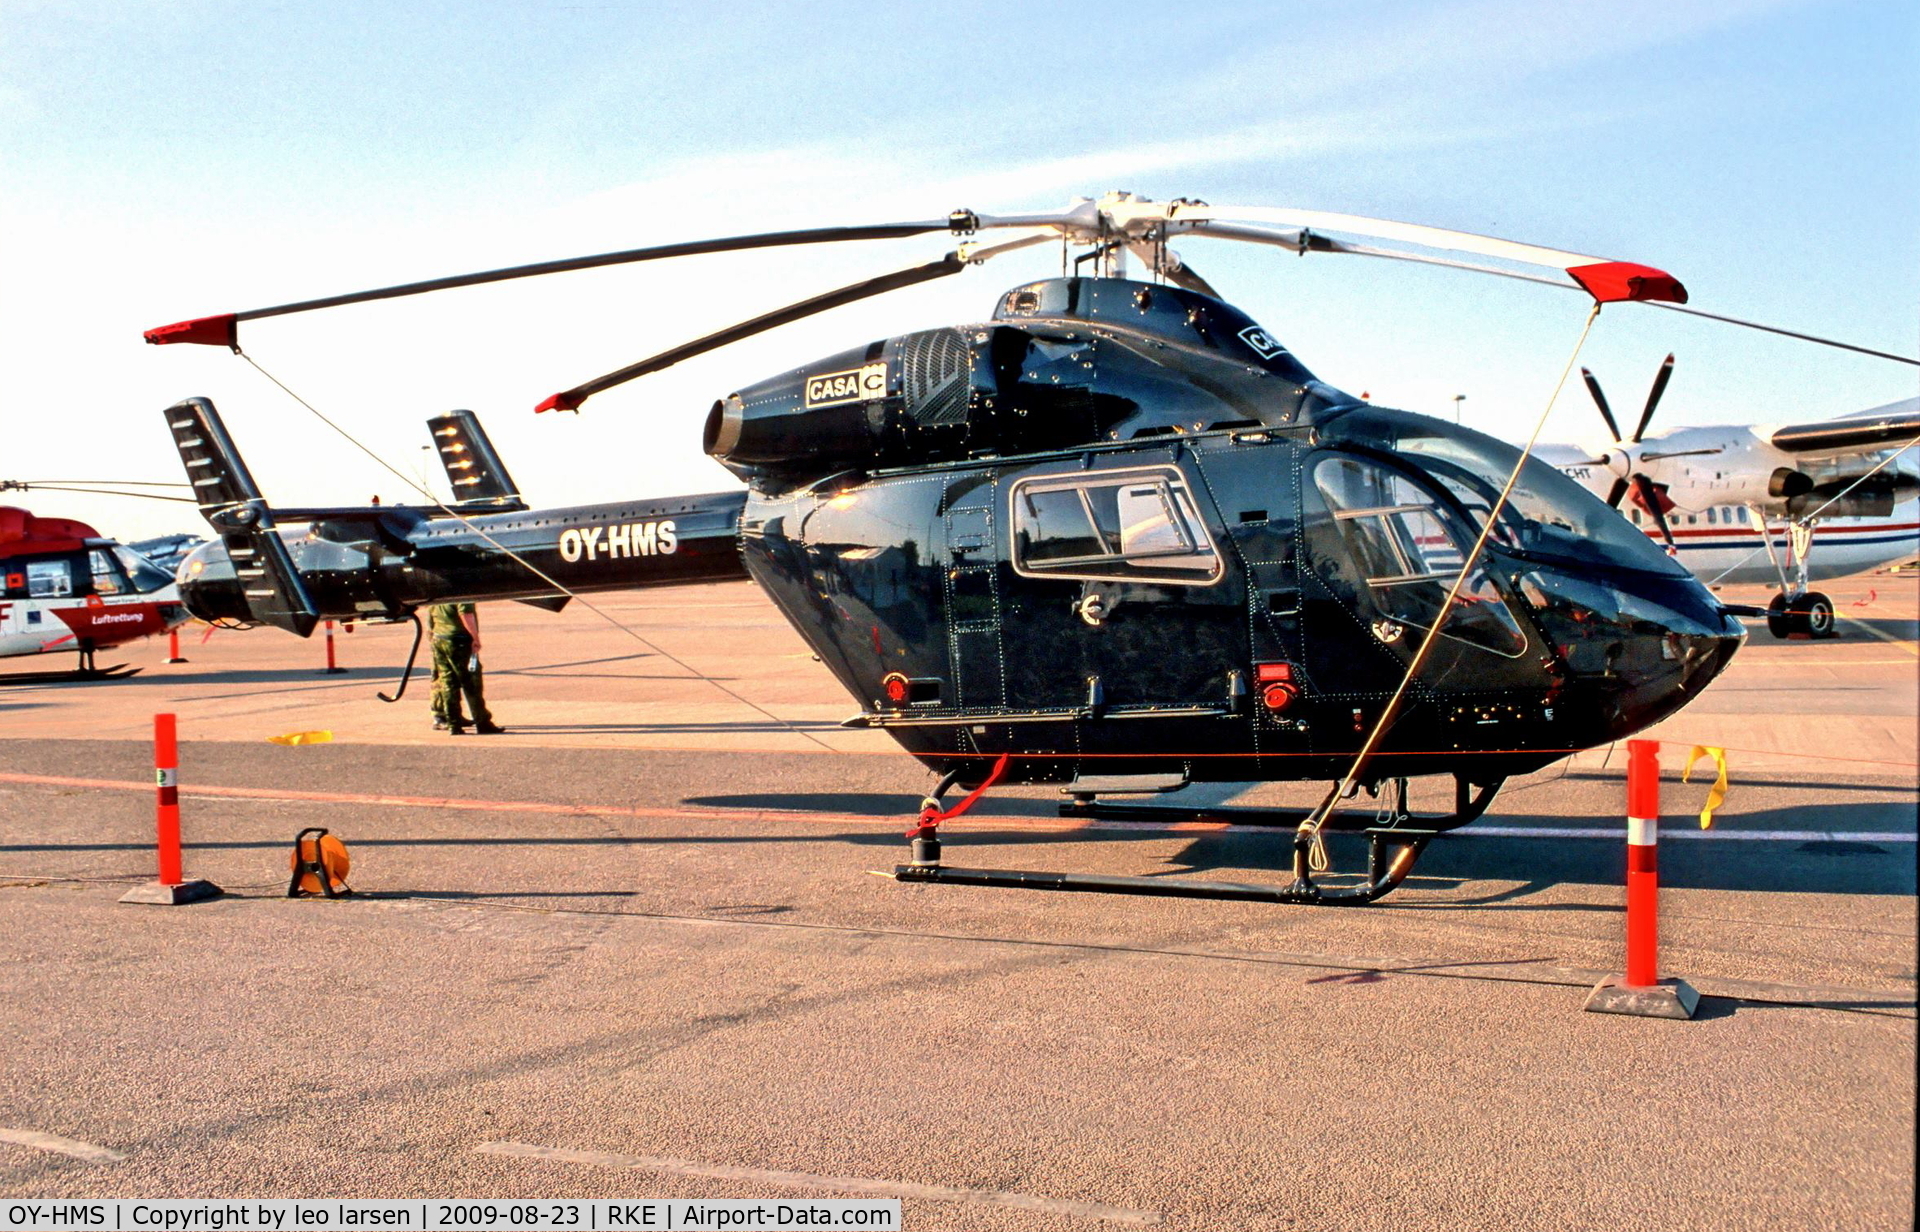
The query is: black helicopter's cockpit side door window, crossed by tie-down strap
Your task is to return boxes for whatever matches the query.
[1313,457,1526,658]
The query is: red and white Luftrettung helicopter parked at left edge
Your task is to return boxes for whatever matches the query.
[0,507,188,681]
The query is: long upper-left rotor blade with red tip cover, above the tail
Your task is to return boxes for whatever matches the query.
[146,211,983,347]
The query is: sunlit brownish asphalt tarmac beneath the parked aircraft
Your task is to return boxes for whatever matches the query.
[0,574,1920,1228]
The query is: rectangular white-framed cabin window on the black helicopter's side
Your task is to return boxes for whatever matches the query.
[1008,466,1221,585]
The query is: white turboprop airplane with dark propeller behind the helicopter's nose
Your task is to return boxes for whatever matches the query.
[1536,355,1920,637]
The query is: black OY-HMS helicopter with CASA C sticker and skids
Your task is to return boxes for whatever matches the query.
[148,194,1766,902]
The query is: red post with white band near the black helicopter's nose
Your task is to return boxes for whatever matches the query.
[1586,741,1699,1019]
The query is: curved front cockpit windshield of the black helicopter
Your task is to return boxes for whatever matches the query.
[1327,409,1686,576]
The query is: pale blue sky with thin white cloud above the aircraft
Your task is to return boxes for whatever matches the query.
[0,0,1920,537]
